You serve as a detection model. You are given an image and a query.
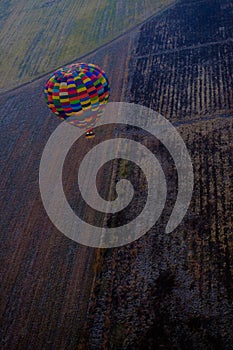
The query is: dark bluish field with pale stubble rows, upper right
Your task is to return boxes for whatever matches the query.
[129,1,233,122]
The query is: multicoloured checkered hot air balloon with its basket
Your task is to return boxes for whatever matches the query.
[44,63,110,138]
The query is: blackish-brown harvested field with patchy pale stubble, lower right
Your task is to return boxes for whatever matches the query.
[81,118,233,350]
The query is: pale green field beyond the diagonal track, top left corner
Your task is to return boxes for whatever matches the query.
[0,0,174,92]
